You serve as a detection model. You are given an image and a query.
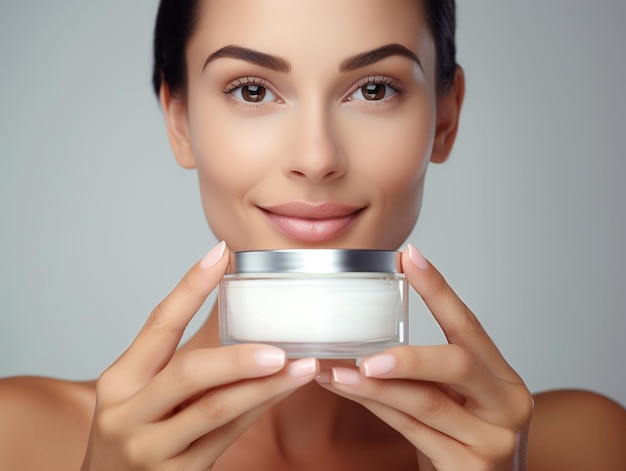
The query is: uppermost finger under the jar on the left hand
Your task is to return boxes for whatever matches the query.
[129,344,286,423]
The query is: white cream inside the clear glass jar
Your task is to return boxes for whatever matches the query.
[226,277,400,343]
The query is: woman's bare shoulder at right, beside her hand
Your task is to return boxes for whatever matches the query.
[529,390,626,471]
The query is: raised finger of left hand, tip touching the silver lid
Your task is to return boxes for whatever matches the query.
[109,242,228,390]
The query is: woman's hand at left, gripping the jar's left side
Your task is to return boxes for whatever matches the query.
[82,242,319,471]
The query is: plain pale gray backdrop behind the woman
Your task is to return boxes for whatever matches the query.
[0,0,626,404]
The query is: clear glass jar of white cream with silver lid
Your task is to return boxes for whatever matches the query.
[218,249,408,358]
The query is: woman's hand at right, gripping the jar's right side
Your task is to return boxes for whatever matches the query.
[322,246,533,471]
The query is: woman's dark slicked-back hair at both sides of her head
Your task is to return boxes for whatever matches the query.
[152,0,456,96]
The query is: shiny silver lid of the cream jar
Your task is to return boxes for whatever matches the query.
[229,249,402,274]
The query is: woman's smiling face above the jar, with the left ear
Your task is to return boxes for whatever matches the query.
[164,0,454,250]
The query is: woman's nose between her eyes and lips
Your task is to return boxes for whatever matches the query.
[283,106,348,184]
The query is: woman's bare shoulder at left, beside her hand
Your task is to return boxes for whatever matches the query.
[0,377,95,470]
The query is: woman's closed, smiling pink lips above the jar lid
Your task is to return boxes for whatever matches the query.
[260,203,364,243]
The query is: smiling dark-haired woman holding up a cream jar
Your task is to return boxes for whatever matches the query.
[0,0,626,470]
